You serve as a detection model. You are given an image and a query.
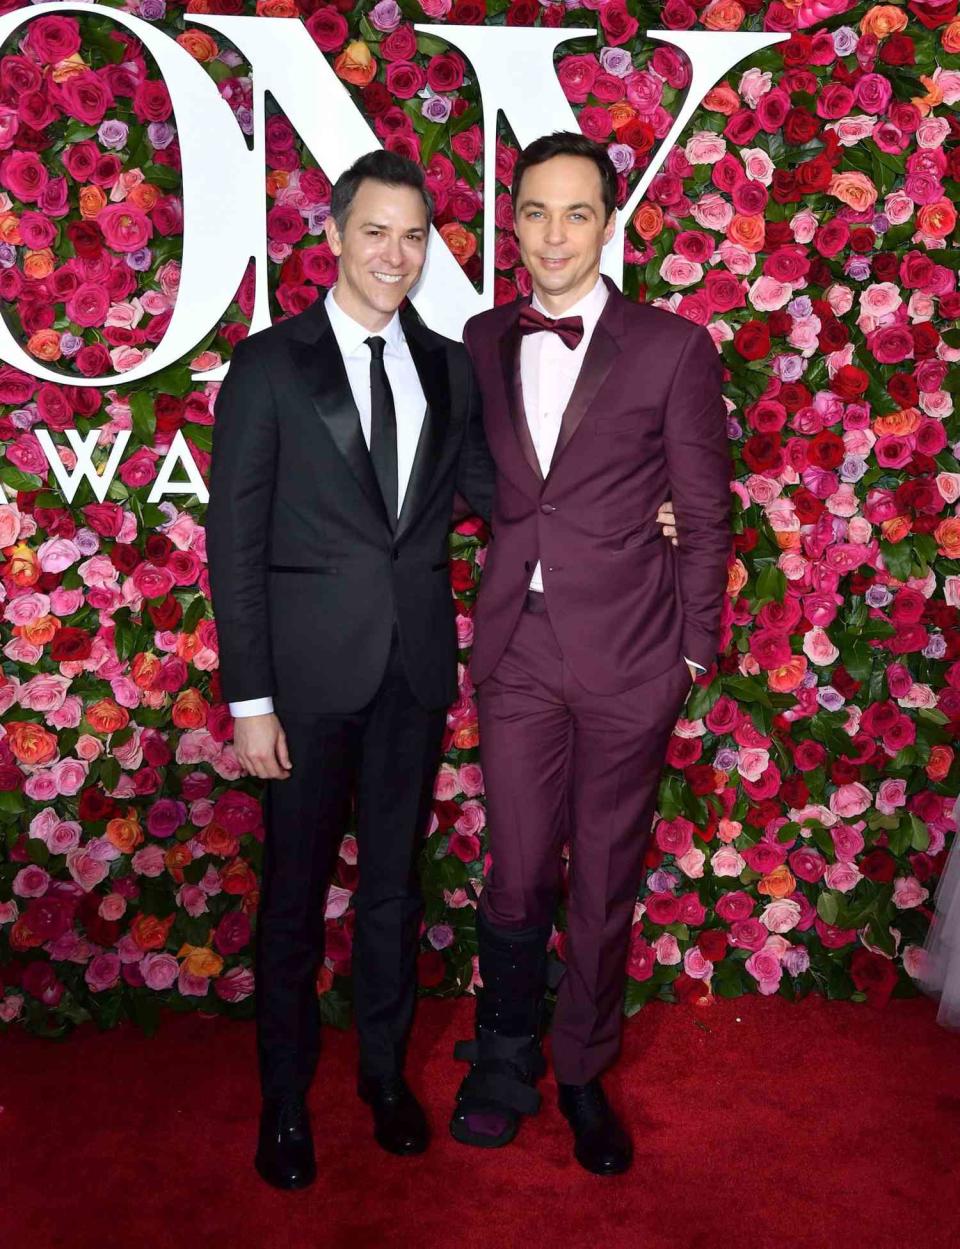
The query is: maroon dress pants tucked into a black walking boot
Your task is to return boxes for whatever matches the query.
[478,595,690,1084]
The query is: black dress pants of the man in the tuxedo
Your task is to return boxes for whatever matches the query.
[256,629,446,1097]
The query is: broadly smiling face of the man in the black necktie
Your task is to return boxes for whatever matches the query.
[326,177,428,333]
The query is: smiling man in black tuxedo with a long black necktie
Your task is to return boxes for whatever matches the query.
[206,151,493,1188]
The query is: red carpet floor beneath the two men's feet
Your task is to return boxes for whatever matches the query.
[0,998,960,1249]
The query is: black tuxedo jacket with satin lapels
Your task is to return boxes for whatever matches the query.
[206,300,493,716]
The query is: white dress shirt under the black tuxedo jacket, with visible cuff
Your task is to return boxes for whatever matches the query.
[228,286,426,717]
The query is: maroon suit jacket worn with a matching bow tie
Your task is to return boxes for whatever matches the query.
[464,279,730,694]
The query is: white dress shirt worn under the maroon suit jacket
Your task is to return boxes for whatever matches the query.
[521,277,705,672]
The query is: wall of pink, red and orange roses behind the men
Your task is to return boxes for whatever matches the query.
[0,0,960,1033]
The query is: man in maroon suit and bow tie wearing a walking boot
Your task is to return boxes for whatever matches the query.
[451,134,730,1174]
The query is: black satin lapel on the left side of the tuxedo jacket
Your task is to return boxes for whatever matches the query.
[290,317,391,528]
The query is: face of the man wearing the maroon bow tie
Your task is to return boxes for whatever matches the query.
[514,156,617,316]
